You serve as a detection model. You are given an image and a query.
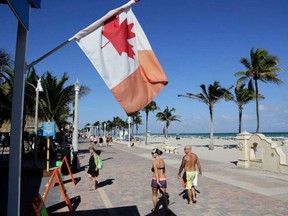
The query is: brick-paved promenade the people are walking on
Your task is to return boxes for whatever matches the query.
[39,142,288,216]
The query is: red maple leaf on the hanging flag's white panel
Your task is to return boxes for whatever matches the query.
[102,17,135,58]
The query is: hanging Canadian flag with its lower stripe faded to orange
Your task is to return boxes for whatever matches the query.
[71,0,168,115]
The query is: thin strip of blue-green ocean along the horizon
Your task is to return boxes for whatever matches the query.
[151,132,288,139]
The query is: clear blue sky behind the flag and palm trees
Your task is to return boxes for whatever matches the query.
[0,0,288,133]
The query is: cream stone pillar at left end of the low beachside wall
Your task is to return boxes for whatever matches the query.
[236,131,252,168]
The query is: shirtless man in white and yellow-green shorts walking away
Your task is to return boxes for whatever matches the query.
[178,145,202,204]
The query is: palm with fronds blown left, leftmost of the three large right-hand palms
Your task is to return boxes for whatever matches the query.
[178,81,233,150]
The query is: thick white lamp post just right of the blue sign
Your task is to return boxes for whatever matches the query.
[72,79,81,172]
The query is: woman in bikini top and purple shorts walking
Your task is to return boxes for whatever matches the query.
[151,148,170,213]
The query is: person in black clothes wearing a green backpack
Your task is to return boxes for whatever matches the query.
[87,146,99,191]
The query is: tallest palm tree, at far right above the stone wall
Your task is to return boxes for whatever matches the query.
[235,48,284,133]
